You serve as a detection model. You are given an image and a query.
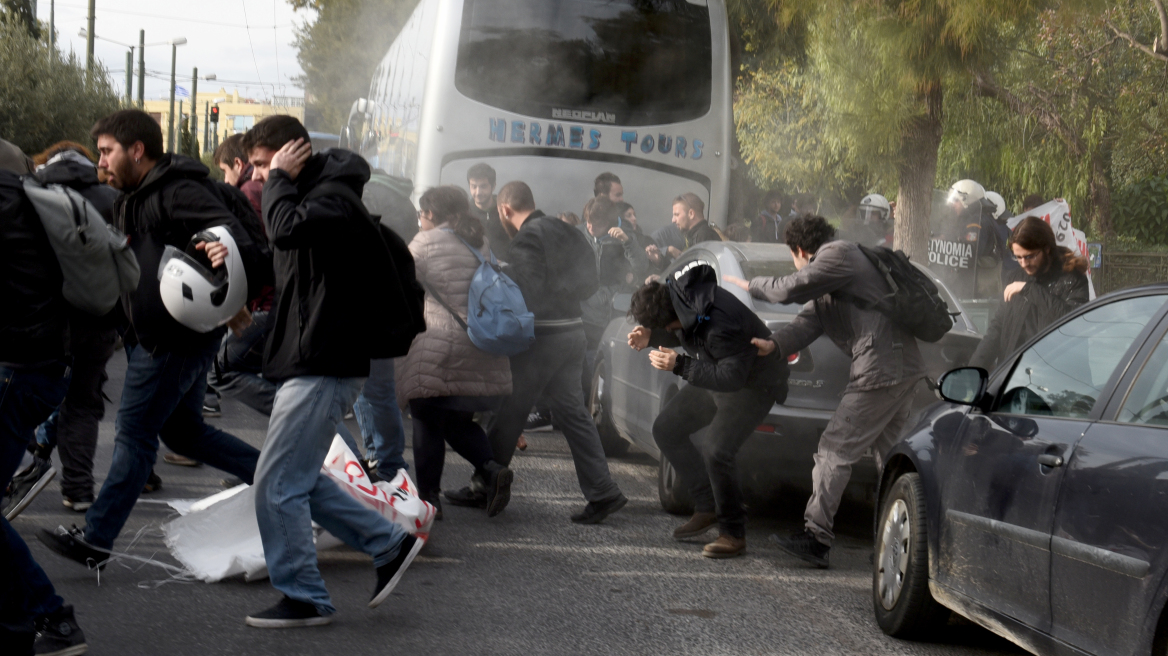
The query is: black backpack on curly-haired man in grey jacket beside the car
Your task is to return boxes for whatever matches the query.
[857,244,953,342]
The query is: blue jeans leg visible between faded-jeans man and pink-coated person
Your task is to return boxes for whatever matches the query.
[353,358,410,469]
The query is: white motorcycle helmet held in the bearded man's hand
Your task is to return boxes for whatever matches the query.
[158,226,248,333]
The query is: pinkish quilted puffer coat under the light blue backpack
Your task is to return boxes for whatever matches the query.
[396,229,512,405]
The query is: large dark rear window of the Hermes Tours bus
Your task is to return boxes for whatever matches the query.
[454,0,712,126]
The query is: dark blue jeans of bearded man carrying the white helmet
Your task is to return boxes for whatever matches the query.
[85,342,259,549]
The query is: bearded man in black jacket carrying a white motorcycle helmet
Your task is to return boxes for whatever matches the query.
[37,110,264,566]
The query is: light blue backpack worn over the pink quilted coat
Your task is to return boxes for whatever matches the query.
[423,230,535,356]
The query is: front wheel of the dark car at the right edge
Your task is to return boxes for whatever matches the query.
[872,473,948,638]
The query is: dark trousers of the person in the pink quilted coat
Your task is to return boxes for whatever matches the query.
[410,398,493,498]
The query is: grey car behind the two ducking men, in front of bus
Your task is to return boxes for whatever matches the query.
[589,242,981,514]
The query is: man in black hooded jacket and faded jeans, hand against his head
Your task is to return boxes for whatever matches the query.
[244,116,423,628]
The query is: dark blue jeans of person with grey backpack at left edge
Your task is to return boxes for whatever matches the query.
[0,363,69,644]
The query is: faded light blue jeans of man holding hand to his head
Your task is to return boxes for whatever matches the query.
[256,376,405,615]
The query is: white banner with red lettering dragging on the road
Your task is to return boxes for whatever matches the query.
[162,435,436,584]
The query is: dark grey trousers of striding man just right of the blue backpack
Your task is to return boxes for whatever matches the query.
[488,328,620,501]
